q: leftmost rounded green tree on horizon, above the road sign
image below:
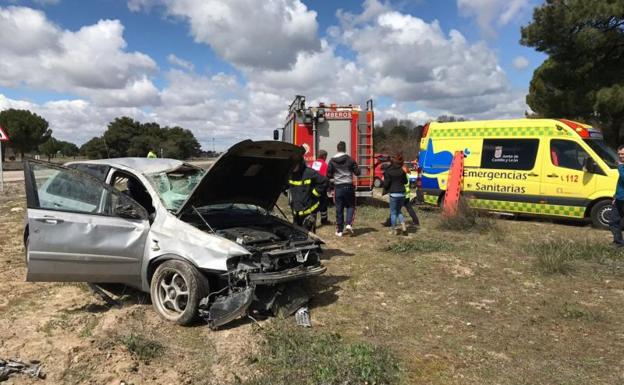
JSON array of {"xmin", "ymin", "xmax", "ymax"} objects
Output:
[{"xmin": 0, "ymin": 108, "xmax": 52, "ymax": 160}]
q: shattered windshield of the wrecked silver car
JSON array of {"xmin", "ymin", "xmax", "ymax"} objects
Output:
[{"xmin": 147, "ymin": 166, "xmax": 206, "ymax": 211}]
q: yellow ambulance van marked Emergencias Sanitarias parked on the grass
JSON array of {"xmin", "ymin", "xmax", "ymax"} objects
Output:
[{"xmin": 419, "ymin": 119, "xmax": 618, "ymax": 228}]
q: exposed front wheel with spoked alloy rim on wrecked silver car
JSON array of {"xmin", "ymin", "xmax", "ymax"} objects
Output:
[{"xmin": 150, "ymin": 260, "xmax": 209, "ymax": 325}]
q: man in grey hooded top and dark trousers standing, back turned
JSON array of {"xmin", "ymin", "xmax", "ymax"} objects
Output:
[{"xmin": 327, "ymin": 141, "xmax": 360, "ymax": 237}]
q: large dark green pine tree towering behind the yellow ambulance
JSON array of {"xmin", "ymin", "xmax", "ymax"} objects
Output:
[{"xmin": 520, "ymin": 0, "xmax": 624, "ymax": 146}]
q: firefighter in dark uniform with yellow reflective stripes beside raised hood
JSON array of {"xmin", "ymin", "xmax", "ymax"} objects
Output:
[{"xmin": 288, "ymin": 158, "xmax": 327, "ymax": 232}]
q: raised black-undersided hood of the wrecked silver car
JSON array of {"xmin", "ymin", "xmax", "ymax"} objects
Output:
[{"xmin": 178, "ymin": 140, "xmax": 304, "ymax": 214}]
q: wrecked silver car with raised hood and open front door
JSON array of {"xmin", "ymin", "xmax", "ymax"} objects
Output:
[{"xmin": 24, "ymin": 140, "xmax": 326, "ymax": 328}]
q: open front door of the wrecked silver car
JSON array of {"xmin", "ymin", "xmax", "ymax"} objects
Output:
[{"xmin": 24, "ymin": 161, "xmax": 149, "ymax": 285}]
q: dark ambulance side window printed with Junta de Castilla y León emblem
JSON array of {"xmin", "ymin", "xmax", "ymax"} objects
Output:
[{"xmin": 481, "ymin": 139, "xmax": 539, "ymax": 170}]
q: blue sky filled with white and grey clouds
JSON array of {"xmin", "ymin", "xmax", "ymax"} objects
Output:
[{"xmin": 0, "ymin": 0, "xmax": 545, "ymax": 150}]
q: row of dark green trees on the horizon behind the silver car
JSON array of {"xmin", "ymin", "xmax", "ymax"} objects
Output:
[{"xmin": 0, "ymin": 109, "xmax": 201, "ymax": 161}]
